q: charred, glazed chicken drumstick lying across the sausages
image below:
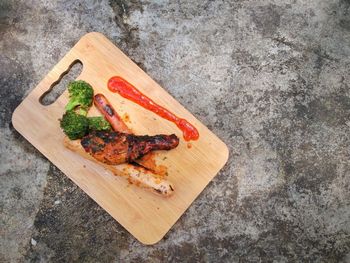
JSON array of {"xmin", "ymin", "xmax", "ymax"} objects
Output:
[{"xmin": 81, "ymin": 131, "xmax": 179, "ymax": 164}]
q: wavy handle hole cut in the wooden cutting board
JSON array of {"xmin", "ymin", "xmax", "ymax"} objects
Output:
[{"xmin": 39, "ymin": 59, "xmax": 83, "ymax": 106}]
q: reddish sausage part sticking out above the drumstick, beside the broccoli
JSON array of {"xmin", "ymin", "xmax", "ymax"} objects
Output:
[{"xmin": 94, "ymin": 93, "xmax": 132, "ymax": 133}]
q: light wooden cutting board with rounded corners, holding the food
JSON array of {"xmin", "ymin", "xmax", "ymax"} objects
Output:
[{"xmin": 12, "ymin": 33, "xmax": 228, "ymax": 244}]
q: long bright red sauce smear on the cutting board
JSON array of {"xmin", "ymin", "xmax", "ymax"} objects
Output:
[{"xmin": 108, "ymin": 77, "xmax": 199, "ymax": 141}]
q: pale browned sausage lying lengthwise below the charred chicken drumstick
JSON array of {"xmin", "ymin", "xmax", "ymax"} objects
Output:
[{"xmin": 64, "ymin": 137, "xmax": 174, "ymax": 197}]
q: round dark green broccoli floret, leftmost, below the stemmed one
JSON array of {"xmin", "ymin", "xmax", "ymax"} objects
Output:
[{"xmin": 60, "ymin": 111, "xmax": 89, "ymax": 140}]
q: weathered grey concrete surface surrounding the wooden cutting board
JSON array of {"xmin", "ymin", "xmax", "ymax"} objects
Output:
[{"xmin": 0, "ymin": 0, "xmax": 350, "ymax": 262}]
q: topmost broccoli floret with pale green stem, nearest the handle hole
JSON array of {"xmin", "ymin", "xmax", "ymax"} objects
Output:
[{"xmin": 66, "ymin": 80, "xmax": 94, "ymax": 116}]
